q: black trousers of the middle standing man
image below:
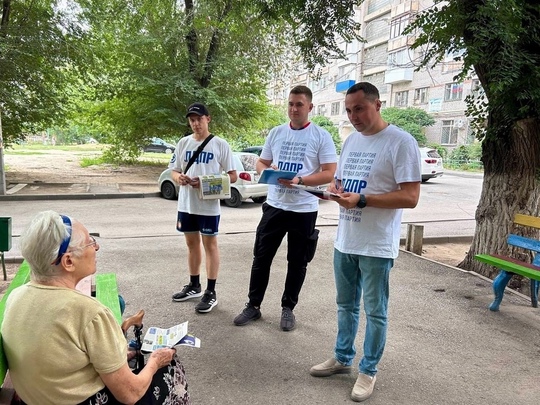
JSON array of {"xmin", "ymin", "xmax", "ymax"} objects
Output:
[{"xmin": 248, "ymin": 203, "xmax": 318, "ymax": 309}]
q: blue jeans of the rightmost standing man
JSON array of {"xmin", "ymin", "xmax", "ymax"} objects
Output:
[{"xmin": 334, "ymin": 249, "xmax": 394, "ymax": 376}]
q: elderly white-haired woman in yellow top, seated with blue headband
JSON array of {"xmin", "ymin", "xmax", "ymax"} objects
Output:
[{"xmin": 2, "ymin": 211, "xmax": 191, "ymax": 405}]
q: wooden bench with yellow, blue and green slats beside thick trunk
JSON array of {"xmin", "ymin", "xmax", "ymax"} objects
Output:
[{"xmin": 475, "ymin": 214, "xmax": 540, "ymax": 311}]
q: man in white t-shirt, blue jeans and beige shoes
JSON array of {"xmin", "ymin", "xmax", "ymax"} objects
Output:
[{"xmin": 310, "ymin": 82, "xmax": 421, "ymax": 402}]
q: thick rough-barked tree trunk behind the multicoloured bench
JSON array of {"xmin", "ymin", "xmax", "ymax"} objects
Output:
[{"xmin": 458, "ymin": 118, "xmax": 540, "ymax": 287}]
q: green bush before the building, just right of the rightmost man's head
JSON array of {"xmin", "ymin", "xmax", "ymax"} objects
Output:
[{"xmin": 381, "ymin": 107, "xmax": 435, "ymax": 146}]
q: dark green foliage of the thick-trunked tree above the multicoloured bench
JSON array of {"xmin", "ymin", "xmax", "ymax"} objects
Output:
[{"xmin": 406, "ymin": 0, "xmax": 540, "ymax": 143}]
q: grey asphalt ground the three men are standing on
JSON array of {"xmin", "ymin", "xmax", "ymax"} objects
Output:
[{"xmin": 0, "ymin": 181, "xmax": 540, "ymax": 405}]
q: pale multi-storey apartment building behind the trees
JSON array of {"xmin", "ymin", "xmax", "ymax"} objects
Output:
[{"xmin": 270, "ymin": 0, "xmax": 481, "ymax": 149}]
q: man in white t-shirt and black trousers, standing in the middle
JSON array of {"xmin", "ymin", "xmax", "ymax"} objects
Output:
[{"xmin": 234, "ymin": 86, "xmax": 337, "ymax": 331}]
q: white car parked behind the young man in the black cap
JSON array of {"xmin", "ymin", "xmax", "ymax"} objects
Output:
[{"xmin": 158, "ymin": 152, "xmax": 268, "ymax": 208}]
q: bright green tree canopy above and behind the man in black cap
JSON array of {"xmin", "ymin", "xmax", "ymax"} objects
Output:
[{"xmin": 0, "ymin": 0, "xmax": 362, "ymax": 155}]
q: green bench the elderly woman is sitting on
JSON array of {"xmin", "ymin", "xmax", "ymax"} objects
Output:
[{"xmin": 0, "ymin": 261, "xmax": 122, "ymax": 405}]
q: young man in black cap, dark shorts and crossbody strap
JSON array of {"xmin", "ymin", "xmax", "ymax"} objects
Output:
[{"xmin": 169, "ymin": 103, "xmax": 237, "ymax": 313}]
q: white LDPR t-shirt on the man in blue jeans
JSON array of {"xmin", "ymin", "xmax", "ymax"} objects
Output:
[{"xmin": 334, "ymin": 125, "xmax": 422, "ymax": 258}]
